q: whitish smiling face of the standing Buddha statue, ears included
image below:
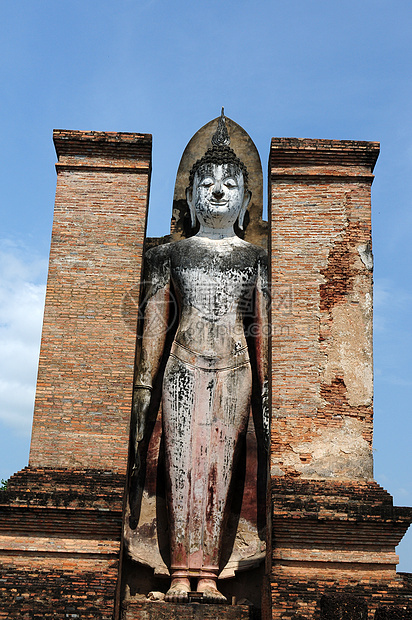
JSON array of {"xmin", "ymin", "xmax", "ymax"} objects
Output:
[{"xmin": 187, "ymin": 164, "xmax": 250, "ymax": 230}]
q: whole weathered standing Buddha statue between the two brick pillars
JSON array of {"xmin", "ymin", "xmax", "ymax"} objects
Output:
[{"xmin": 130, "ymin": 110, "xmax": 269, "ymax": 602}]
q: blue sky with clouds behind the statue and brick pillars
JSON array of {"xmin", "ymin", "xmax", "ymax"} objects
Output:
[{"xmin": 0, "ymin": 0, "xmax": 412, "ymax": 572}]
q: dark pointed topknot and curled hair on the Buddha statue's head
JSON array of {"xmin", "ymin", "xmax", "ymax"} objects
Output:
[{"xmin": 189, "ymin": 108, "xmax": 248, "ymax": 189}]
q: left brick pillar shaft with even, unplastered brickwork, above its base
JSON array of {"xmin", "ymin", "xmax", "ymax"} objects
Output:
[{"xmin": 30, "ymin": 130, "xmax": 151, "ymax": 473}]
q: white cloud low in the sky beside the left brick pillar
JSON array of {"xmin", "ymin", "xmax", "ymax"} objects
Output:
[{"xmin": 0, "ymin": 240, "xmax": 47, "ymax": 435}]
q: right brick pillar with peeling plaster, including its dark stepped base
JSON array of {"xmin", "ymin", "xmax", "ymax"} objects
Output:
[{"xmin": 264, "ymin": 138, "xmax": 412, "ymax": 620}]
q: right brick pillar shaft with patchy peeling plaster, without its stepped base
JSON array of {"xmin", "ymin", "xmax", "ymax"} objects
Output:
[{"xmin": 269, "ymin": 138, "xmax": 379, "ymax": 480}]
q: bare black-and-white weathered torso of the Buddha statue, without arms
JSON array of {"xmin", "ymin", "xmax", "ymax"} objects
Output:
[{"xmin": 165, "ymin": 236, "xmax": 265, "ymax": 358}]
